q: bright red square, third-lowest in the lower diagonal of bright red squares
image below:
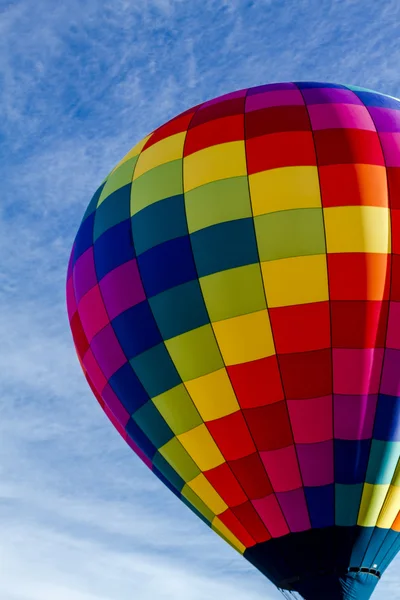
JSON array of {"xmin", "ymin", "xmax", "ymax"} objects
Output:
[{"xmin": 206, "ymin": 411, "xmax": 255, "ymax": 460}]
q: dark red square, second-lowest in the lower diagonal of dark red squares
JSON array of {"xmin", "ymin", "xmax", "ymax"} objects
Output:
[{"xmin": 229, "ymin": 452, "xmax": 272, "ymax": 500}]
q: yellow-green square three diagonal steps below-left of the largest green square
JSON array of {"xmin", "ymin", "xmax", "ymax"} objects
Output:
[{"xmin": 153, "ymin": 385, "xmax": 203, "ymax": 435}]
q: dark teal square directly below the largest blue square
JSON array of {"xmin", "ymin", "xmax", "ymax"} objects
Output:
[{"xmin": 149, "ymin": 279, "xmax": 209, "ymax": 340}]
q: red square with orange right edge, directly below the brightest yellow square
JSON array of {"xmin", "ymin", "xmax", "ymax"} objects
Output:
[{"xmin": 327, "ymin": 252, "xmax": 391, "ymax": 300}]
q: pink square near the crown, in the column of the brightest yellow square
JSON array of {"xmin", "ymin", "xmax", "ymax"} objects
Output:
[{"xmin": 308, "ymin": 104, "xmax": 375, "ymax": 131}]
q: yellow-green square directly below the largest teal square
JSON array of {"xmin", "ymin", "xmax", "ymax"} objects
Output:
[{"xmin": 200, "ymin": 263, "xmax": 267, "ymax": 321}]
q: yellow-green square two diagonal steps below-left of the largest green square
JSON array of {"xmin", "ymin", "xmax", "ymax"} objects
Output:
[{"xmin": 165, "ymin": 325, "xmax": 224, "ymax": 381}]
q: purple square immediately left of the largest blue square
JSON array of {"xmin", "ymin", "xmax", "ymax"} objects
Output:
[{"xmin": 100, "ymin": 260, "xmax": 146, "ymax": 320}]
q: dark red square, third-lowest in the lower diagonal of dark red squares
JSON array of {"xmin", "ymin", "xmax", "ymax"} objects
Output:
[{"xmin": 243, "ymin": 401, "xmax": 293, "ymax": 451}]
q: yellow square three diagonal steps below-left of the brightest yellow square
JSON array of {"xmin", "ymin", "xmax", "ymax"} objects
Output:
[{"xmin": 185, "ymin": 369, "xmax": 240, "ymax": 421}]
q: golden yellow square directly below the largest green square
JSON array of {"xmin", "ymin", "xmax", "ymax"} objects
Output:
[{"xmin": 261, "ymin": 254, "xmax": 329, "ymax": 308}]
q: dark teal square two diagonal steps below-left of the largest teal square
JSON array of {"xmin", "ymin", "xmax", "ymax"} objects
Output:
[{"xmin": 130, "ymin": 344, "xmax": 182, "ymax": 398}]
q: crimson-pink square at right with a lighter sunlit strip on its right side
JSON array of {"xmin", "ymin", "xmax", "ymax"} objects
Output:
[{"xmin": 332, "ymin": 348, "xmax": 383, "ymax": 395}]
